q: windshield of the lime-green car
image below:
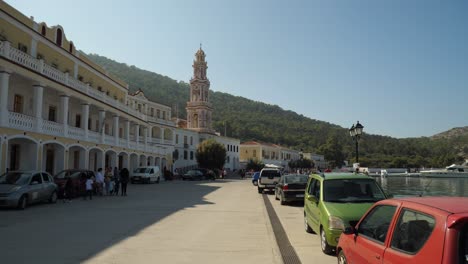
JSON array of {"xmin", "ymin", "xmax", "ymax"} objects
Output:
[{"xmin": 323, "ymin": 179, "xmax": 385, "ymax": 203}]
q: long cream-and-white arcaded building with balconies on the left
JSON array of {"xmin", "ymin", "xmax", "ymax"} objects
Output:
[{"xmin": 0, "ymin": 1, "xmax": 176, "ymax": 174}]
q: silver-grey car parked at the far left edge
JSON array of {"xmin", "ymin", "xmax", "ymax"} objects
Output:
[{"xmin": 0, "ymin": 171, "xmax": 57, "ymax": 209}]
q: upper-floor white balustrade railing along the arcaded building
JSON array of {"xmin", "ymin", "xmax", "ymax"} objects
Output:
[{"xmin": 0, "ymin": 41, "xmax": 168, "ymax": 125}]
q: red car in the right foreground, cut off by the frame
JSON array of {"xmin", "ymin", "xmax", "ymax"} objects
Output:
[{"xmin": 336, "ymin": 197, "xmax": 468, "ymax": 264}]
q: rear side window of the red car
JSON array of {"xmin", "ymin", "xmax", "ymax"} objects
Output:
[{"xmin": 391, "ymin": 209, "xmax": 435, "ymax": 253}]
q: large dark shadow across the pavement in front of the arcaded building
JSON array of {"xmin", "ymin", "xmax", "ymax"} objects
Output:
[{"xmin": 0, "ymin": 180, "xmax": 223, "ymax": 264}]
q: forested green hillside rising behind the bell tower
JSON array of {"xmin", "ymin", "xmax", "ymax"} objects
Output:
[{"xmin": 88, "ymin": 54, "xmax": 468, "ymax": 167}]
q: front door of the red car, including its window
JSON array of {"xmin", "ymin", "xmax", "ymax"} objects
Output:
[{"xmin": 348, "ymin": 204, "xmax": 398, "ymax": 263}]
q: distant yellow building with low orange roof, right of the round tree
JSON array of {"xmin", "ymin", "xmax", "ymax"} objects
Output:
[{"xmin": 239, "ymin": 141, "xmax": 300, "ymax": 169}]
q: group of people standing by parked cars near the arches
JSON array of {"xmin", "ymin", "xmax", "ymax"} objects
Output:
[{"xmin": 84, "ymin": 167, "xmax": 130, "ymax": 200}]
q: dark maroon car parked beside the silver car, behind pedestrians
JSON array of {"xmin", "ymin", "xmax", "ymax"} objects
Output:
[{"xmin": 54, "ymin": 169, "xmax": 95, "ymax": 198}]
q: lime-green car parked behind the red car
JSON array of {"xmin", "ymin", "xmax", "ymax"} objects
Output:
[{"xmin": 304, "ymin": 173, "xmax": 387, "ymax": 254}]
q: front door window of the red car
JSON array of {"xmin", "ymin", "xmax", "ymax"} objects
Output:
[{"xmin": 358, "ymin": 205, "xmax": 396, "ymax": 244}]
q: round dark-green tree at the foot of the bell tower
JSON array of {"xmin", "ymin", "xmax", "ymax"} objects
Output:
[{"xmin": 195, "ymin": 139, "xmax": 226, "ymax": 169}]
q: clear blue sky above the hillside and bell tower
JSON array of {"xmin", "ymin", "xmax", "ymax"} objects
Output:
[{"xmin": 6, "ymin": 0, "xmax": 468, "ymax": 137}]
